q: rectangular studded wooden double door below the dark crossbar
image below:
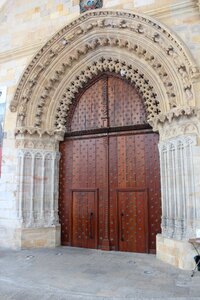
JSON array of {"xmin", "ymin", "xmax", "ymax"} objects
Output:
[{"xmin": 59, "ymin": 75, "xmax": 160, "ymax": 252}]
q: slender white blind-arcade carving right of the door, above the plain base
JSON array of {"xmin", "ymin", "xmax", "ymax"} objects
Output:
[{"xmin": 159, "ymin": 136, "xmax": 197, "ymax": 240}]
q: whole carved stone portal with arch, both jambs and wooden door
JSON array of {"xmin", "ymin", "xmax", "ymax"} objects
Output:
[{"xmin": 8, "ymin": 9, "xmax": 200, "ymax": 268}]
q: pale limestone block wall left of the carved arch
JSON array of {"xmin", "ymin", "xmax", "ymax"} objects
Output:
[{"xmin": 0, "ymin": 0, "xmax": 79, "ymax": 248}]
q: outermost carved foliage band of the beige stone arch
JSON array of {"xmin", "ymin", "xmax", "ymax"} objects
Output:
[{"xmin": 10, "ymin": 10, "xmax": 199, "ymax": 131}]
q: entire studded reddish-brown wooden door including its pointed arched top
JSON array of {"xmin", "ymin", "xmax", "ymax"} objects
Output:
[{"xmin": 59, "ymin": 73, "xmax": 161, "ymax": 252}]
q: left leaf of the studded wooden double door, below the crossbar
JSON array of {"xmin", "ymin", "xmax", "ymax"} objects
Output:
[{"xmin": 59, "ymin": 137, "xmax": 108, "ymax": 248}]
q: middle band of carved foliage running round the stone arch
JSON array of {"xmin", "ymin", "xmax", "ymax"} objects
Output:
[{"xmin": 18, "ymin": 37, "xmax": 172, "ymax": 126}]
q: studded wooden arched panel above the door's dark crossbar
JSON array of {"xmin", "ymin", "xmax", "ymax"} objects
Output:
[{"xmin": 67, "ymin": 74, "xmax": 147, "ymax": 132}]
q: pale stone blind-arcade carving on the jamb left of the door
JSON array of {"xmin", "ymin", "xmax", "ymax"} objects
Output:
[{"xmin": 17, "ymin": 147, "xmax": 59, "ymax": 228}]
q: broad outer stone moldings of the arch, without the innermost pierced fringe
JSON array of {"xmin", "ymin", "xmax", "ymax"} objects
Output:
[{"xmin": 10, "ymin": 10, "xmax": 199, "ymax": 131}]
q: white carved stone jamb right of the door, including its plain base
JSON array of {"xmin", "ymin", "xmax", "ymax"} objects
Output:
[{"xmin": 157, "ymin": 131, "xmax": 200, "ymax": 269}]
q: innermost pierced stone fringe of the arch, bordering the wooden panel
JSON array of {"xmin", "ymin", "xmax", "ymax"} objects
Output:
[{"xmin": 35, "ymin": 57, "xmax": 160, "ymax": 128}]
